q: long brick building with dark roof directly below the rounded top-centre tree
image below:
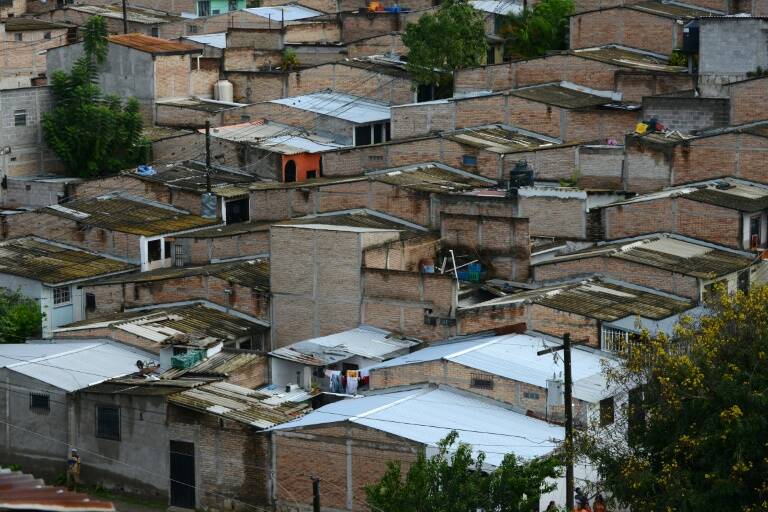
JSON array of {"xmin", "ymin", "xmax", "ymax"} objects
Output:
[{"xmin": 391, "ymin": 82, "xmax": 639, "ymax": 142}]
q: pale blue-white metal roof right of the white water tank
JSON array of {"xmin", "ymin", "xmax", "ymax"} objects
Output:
[{"xmin": 270, "ymin": 91, "xmax": 390, "ymax": 124}]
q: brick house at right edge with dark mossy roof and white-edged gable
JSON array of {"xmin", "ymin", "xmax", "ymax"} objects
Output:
[{"xmin": 600, "ymin": 178, "xmax": 768, "ymax": 251}]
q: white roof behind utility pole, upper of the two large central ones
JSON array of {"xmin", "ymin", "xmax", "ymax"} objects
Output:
[{"xmin": 369, "ymin": 334, "xmax": 611, "ymax": 403}]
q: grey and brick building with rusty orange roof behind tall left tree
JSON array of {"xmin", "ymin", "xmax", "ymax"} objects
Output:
[{"xmin": 47, "ymin": 33, "xmax": 206, "ymax": 124}]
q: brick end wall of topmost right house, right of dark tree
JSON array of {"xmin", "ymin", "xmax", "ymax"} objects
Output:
[{"xmin": 570, "ymin": 8, "xmax": 683, "ymax": 55}]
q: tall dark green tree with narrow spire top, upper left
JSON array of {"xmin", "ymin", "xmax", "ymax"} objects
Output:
[{"xmin": 43, "ymin": 16, "xmax": 147, "ymax": 177}]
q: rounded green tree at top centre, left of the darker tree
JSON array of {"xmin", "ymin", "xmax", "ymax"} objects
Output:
[{"xmin": 403, "ymin": 0, "xmax": 488, "ymax": 86}]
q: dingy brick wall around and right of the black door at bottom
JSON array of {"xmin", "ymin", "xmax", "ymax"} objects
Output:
[{"xmin": 168, "ymin": 404, "xmax": 270, "ymax": 512}]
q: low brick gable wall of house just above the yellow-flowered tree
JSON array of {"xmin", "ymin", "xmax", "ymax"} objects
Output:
[{"xmin": 533, "ymin": 256, "xmax": 699, "ymax": 300}]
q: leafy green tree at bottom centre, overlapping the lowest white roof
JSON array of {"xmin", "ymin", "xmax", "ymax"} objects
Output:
[{"xmin": 366, "ymin": 431, "xmax": 560, "ymax": 512}]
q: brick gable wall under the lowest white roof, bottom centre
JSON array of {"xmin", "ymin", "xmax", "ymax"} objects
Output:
[{"xmin": 272, "ymin": 422, "xmax": 422, "ymax": 512}]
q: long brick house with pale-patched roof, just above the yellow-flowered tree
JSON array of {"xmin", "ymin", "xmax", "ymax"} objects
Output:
[{"xmin": 531, "ymin": 233, "xmax": 764, "ymax": 301}]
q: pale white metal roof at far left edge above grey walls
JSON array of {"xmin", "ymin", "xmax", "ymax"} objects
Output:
[{"xmin": 0, "ymin": 342, "xmax": 151, "ymax": 391}]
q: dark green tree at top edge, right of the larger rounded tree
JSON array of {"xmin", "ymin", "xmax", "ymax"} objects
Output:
[{"xmin": 501, "ymin": 0, "xmax": 574, "ymax": 59}]
